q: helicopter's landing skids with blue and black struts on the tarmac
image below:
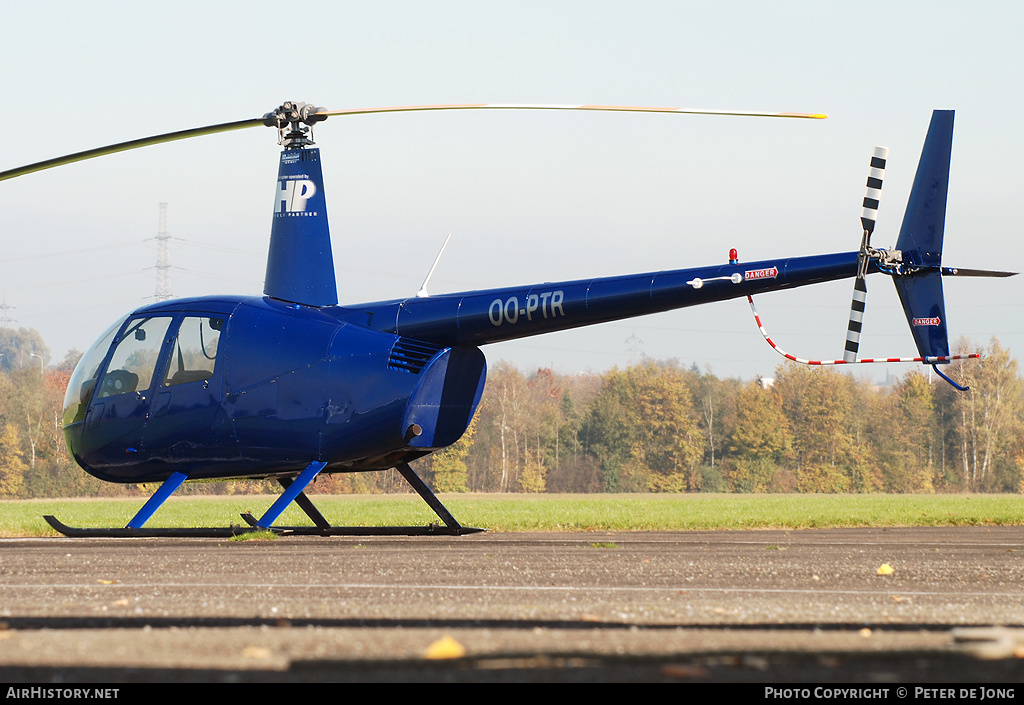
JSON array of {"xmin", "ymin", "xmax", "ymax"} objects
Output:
[{"xmin": 43, "ymin": 463, "xmax": 485, "ymax": 538}]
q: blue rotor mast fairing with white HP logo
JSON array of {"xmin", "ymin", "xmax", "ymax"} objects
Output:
[{"xmin": 263, "ymin": 149, "xmax": 338, "ymax": 306}]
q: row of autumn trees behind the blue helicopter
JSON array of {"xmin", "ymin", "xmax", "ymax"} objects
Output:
[{"xmin": 0, "ymin": 329, "xmax": 1024, "ymax": 498}]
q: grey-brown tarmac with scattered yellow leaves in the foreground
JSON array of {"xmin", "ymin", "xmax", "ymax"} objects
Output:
[{"xmin": 0, "ymin": 527, "xmax": 1024, "ymax": 692}]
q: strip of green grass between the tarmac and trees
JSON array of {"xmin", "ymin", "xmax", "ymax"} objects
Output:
[{"xmin": 0, "ymin": 494, "xmax": 1024, "ymax": 537}]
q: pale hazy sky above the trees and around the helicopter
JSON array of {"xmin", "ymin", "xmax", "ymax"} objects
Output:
[{"xmin": 0, "ymin": 0, "xmax": 1024, "ymax": 380}]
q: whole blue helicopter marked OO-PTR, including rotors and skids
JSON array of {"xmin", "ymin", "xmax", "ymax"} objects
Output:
[{"xmin": 0, "ymin": 102, "xmax": 1010, "ymax": 536}]
